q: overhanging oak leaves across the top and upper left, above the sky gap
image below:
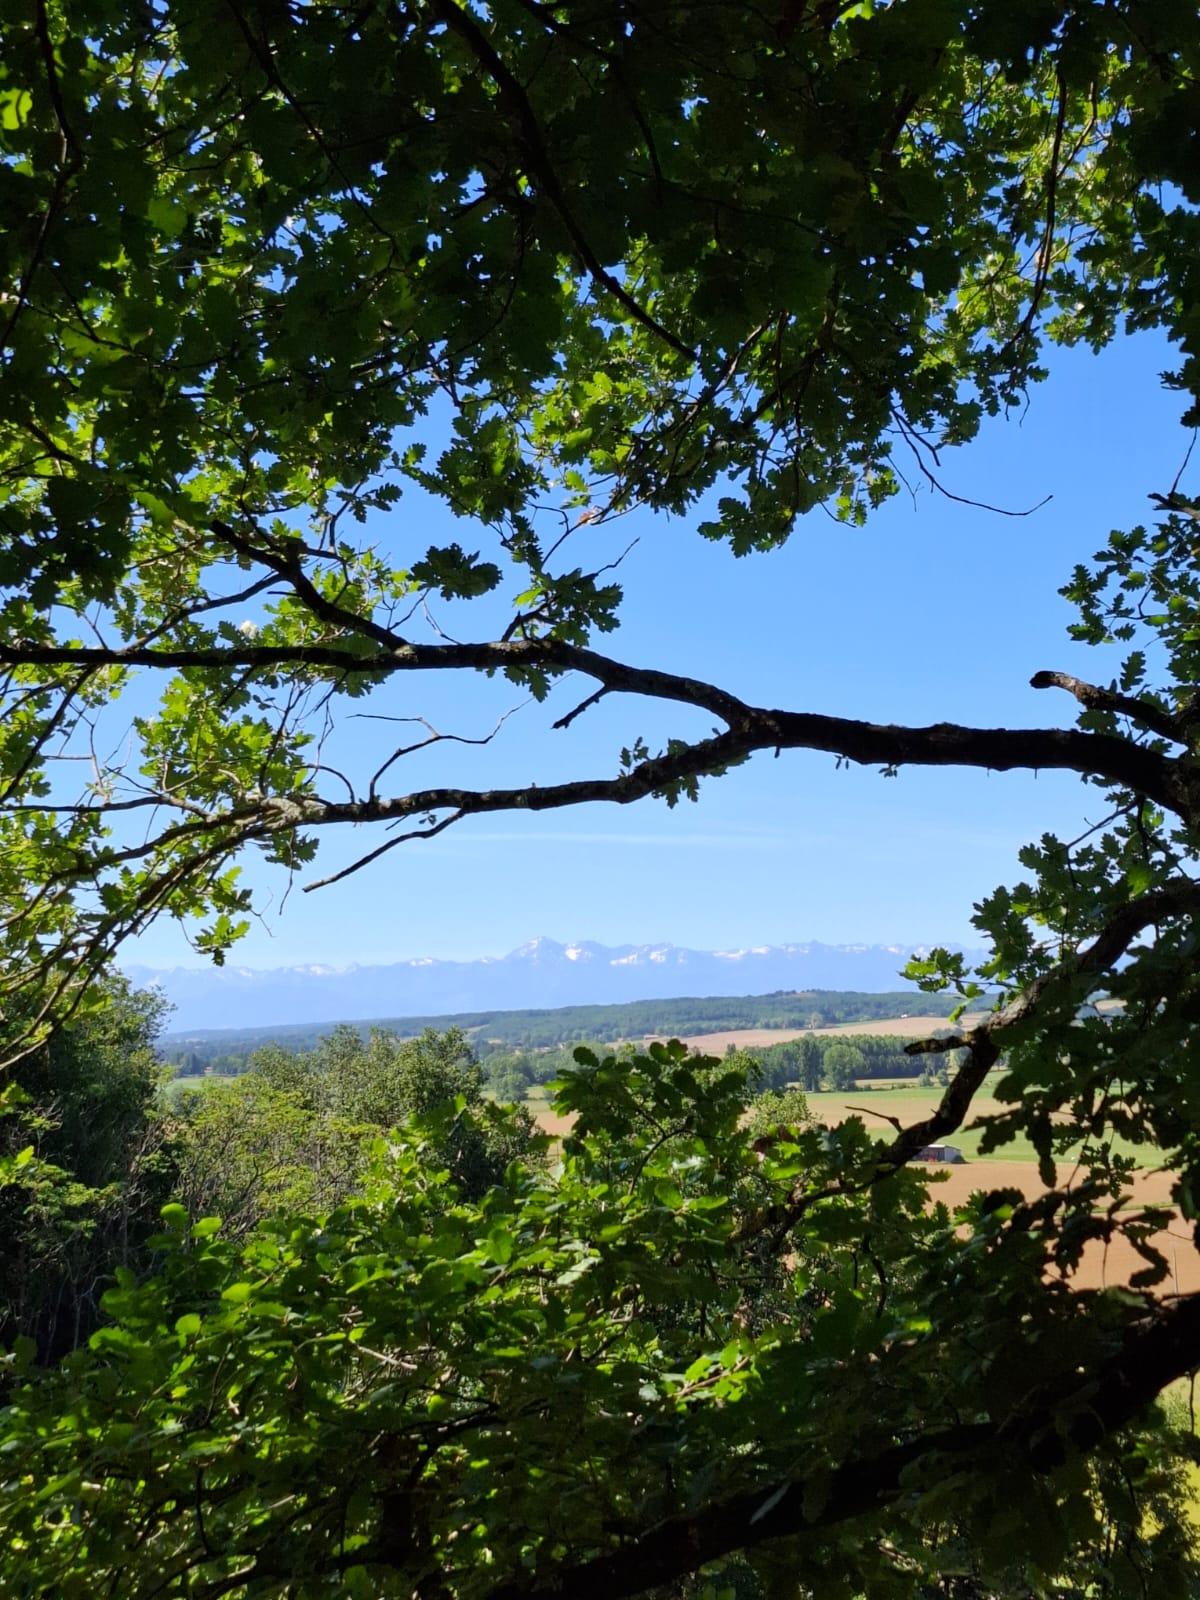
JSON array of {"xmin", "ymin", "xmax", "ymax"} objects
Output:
[{"xmin": 0, "ymin": 0, "xmax": 1200, "ymax": 1017}]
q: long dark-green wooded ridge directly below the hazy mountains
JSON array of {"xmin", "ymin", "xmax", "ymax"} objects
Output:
[{"xmin": 160, "ymin": 989, "xmax": 955, "ymax": 1080}]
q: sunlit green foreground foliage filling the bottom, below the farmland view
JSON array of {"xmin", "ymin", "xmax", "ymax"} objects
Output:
[{"xmin": 0, "ymin": 1046, "xmax": 1197, "ymax": 1600}]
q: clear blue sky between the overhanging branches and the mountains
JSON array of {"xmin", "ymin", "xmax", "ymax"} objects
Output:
[{"xmin": 125, "ymin": 339, "xmax": 1187, "ymax": 966}]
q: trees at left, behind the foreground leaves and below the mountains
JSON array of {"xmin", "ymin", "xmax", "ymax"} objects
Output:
[{"xmin": 0, "ymin": 978, "xmax": 536, "ymax": 1356}]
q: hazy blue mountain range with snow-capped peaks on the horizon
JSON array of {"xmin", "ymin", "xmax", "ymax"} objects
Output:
[{"xmin": 126, "ymin": 939, "xmax": 982, "ymax": 1034}]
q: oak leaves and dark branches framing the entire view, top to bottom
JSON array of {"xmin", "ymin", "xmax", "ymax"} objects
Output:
[{"xmin": 0, "ymin": 0, "xmax": 1200, "ymax": 1597}]
